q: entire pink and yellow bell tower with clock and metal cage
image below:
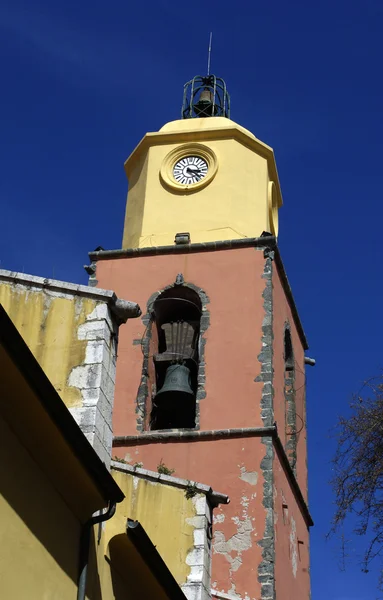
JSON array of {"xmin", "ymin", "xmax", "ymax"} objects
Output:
[{"xmin": 88, "ymin": 75, "xmax": 312, "ymax": 600}]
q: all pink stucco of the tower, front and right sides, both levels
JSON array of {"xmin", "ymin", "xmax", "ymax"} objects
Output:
[{"xmin": 97, "ymin": 248, "xmax": 309, "ymax": 600}]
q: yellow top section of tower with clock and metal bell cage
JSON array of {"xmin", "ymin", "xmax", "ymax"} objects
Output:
[{"xmin": 123, "ymin": 75, "xmax": 282, "ymax": 248}]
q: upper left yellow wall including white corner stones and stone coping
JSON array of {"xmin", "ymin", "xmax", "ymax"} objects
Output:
[{"xmin": 0, "ymin": 270, "xmax": 139, "ymax": 465}]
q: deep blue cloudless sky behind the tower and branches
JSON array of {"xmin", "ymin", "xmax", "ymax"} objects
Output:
[{"xmin": 0, "ymin": 0, "xmax": 383, "ymax": 600}]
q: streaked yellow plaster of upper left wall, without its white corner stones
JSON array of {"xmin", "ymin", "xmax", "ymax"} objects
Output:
[{"xmin": 0, "ymin": 282, "xmax": 97, "ymax": 407}]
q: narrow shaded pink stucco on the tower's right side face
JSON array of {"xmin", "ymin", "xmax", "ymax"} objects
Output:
[{"xmin": 273, "ymin": 265, "xmax": 310, "ymax": 600}]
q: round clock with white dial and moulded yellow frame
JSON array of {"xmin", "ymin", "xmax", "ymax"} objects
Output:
[{"xmin": 160, "ymin": 143, "xmax": 218, "ymax": 193}]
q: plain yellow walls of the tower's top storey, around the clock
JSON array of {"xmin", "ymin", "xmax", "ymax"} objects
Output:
[{"xmin": 123, "ymin": 117, "xmax": 282, "ymax": 248}]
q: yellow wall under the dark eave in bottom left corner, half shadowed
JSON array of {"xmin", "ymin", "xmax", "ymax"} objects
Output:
[{"xmin": 0, "ymin": 417, "xmax": 80, "ymax": 600}]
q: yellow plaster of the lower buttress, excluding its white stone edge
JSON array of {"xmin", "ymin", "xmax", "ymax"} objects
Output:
[{"xmin": 105, "ymin": 470, "xmax": 196, "ymax": 585}]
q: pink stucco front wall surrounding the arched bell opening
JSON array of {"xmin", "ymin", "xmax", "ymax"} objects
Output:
[{"xmin": 97, "ymin": 248, "xmax": 265, "ymax": 435}]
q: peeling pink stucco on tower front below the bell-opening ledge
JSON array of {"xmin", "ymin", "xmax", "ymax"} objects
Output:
[{"xmin": 115, "ymin": 438, "xmax": 265, "ymax": 600}]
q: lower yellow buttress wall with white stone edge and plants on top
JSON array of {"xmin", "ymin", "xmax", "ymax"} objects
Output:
[{"xmin": 107, "ymin": 461, "xmax": 228, "ymax": 600}]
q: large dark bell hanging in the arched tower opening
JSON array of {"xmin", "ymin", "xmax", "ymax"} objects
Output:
[{"xmin": 155, "ymin": 365, "xmax": 194, "ymax": 407}]
